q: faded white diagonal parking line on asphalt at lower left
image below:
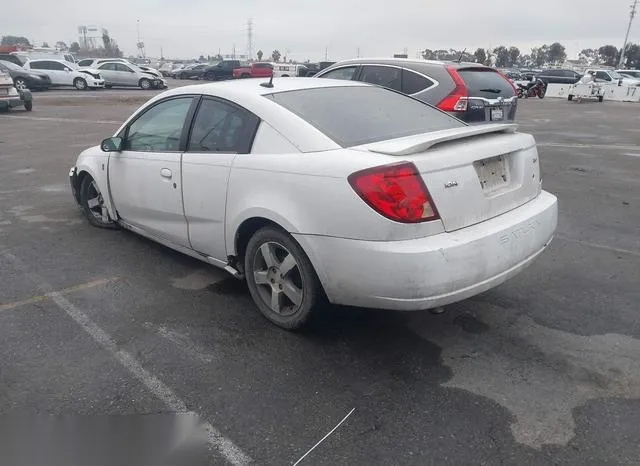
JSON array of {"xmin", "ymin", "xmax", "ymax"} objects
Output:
[{"xmin": 3, "ymin": 253, "xmax": 252, "ymax": 465}]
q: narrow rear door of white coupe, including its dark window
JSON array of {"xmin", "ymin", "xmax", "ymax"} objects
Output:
[{"xmin": 182, "ymin": 97, "xmax": 260, "ymax": 262}]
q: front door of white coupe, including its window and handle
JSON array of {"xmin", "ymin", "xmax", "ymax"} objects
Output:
[{"xmin": 108, "ymin": 96, "xmax": 195, "ymax": 246}]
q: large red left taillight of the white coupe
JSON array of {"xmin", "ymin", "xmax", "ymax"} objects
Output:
[{"xmin": 349, "ymin": 162, "xmax": 440, "ymax": 223}]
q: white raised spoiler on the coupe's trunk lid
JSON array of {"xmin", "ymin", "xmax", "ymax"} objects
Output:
[{"xmin": 361, "ymin": 123, "xmax": 518, "ymax": 155}]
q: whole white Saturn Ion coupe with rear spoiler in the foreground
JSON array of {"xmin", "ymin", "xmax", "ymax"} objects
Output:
[{"xmin": 70, "ymin": 78, "xmax": 558, "ymax": 329}]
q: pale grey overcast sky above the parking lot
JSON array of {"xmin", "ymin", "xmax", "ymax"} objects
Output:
[{"xmin": 0, "ymin": 0, "xmax": 640, "ymax": 60}]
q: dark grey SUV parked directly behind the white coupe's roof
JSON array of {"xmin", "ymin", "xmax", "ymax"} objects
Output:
[{"xmin": 314, "ymin": 58, "xmax": 518, "ymax": 123}]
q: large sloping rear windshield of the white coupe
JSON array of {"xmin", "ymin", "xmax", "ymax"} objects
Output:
[{"xmin": 266, "ymin": 86, "xmax": 465, "ymax": 147}]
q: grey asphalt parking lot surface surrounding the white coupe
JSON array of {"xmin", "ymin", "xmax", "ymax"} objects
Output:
[{"xmin": 0, "ymin": 84, "xmax": 640, "ymax": 465}]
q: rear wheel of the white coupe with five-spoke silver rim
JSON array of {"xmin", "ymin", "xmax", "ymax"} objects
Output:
[{"xmin": 244, "ymin": 227, "xmax": 324, "ymax": 330}]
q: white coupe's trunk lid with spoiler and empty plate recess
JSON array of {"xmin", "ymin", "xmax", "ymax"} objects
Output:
[{"xmin": 355, "ymin": 124, "xmax": 541, "ymax": 231}]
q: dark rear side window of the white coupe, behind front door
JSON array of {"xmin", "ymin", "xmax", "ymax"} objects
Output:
[{"xmin": 187, "ymin": 99, "xmax": 259, "ymax": 154}]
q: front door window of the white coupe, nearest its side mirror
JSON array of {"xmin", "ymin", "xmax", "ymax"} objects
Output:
[{"xmin": 124, "ymin": 97, "xmax": 193, "ymax": 152}]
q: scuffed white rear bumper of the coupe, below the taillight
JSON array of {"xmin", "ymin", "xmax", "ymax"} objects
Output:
[{"xmin": 294, "ymin": 191, "xmax": 558, "ymax": 311}]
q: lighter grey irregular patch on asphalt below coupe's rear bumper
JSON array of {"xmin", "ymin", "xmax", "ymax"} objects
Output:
[{"xmin": 408, "ymin": 301, "xmax": 640, "ymax": 448}]
